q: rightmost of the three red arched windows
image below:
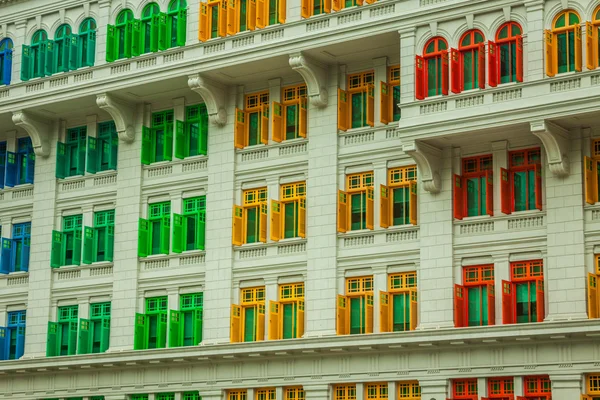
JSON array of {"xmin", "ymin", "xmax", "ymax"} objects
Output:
[{"xmin": 488, "ymin": 22, "xmax": 523, "ymax": 87}]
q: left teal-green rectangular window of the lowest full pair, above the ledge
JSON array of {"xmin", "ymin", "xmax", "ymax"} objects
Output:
[{"xmin": 46, "ymin": 305, "xmax": 79, "ymax": 357}]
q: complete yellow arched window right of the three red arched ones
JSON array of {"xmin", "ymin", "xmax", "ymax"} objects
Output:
[{"xmin": 545, "ymin": 10, "xmax": 581, "ymax": 76}]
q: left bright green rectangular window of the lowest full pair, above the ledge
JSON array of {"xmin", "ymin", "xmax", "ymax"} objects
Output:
[{"xmin": 133, "ymin": 296, "xmax": 168, "ymax": 350}]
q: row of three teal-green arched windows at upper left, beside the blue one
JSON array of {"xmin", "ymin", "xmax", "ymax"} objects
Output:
[{"xmin": 19, "ymin": 18, "xmax": 96, "ymax": 81}]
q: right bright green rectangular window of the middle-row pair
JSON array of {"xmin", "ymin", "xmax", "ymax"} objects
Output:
[{"xmin": 173, "ymin": 196, "xmax": 206, "ymax": 253}]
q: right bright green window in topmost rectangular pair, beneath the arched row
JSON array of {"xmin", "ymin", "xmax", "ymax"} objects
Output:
[{"xmin": 175, "ymin": 104, "xmax": 208, "ymax": 159}]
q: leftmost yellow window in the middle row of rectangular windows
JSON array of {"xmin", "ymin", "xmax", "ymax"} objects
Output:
[{"xmin": 233, "ymin": 187, "xmax": 267, "ymax": 246}]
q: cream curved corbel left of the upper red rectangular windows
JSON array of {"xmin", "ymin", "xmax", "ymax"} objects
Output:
[{"xmin": 402, "ymin": 140, "xmax": 442, "ymax": 193}]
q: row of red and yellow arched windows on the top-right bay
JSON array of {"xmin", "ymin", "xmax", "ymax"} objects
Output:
[{"xmin": 415, "ymin": 7, "xmax": 600, "ymax": 100}]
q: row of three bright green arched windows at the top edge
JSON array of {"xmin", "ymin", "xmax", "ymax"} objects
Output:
[{"xmin": 106, "ymin": 0, "xmax": 187, "ymax": 62}]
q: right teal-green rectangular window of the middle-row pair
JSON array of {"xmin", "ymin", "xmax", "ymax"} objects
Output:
[{"xmin": 83, "ymin": 210, "xmax": 115, "ymax": 264}]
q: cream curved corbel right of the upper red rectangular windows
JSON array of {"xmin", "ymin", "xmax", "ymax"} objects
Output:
[{"xmin": 530, "ymin": 120, "xmax": 569, "ymax": 177}]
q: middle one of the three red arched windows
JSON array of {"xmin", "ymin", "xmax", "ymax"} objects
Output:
[{"xmin": 458, "ymin": 29, "xmax": 485, "ymax": 93}]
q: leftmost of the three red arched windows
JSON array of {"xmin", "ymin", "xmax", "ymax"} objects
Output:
[{"xmin": 415, "ymin": 37, "xmax": 448, "ymax": 100}]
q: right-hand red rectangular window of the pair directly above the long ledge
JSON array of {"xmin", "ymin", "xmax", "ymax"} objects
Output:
[{"xmin": 502, "ymin": 260, "xmax": 546, "ymax": 324}]
